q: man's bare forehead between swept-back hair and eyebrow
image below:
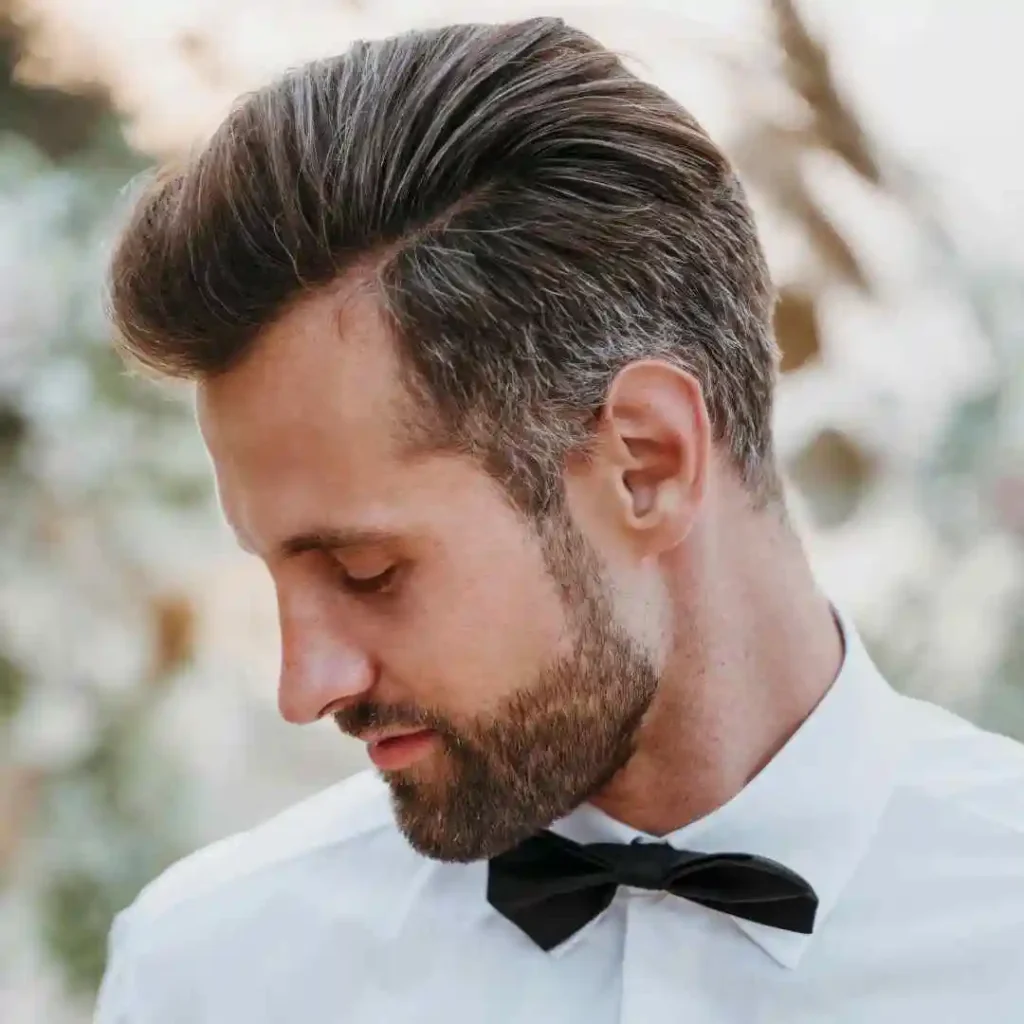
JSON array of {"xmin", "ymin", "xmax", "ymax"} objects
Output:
[{"xmin": 196, "ymin": 284, "xmax": 417, "ymax": 555}]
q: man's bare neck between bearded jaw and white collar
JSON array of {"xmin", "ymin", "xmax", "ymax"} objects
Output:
[{"xmin": 591, "ymin": 507, "xmax": 843, "ymax": 836}]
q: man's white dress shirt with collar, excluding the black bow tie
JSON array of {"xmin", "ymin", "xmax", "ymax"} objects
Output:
[{"xmin": 96, "ymin": 623, "xmax": 1024, "ymax": 1024}]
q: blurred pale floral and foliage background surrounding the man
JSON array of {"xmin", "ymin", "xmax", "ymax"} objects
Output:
[{"xmin": 0, "ymin": 0, "xmax": 1024, "ymax": 1024}]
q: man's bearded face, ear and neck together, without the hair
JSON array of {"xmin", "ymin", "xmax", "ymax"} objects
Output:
[{"xmin": 197, "ymin": 279, "xmax": 842, "ymax": 860}]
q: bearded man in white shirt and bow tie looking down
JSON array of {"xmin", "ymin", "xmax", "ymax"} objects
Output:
[{"xmin": 97, "ymin": 19, "xmax": 1024, "ymax": 1024}]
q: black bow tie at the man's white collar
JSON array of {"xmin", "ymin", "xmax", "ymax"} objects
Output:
[{"xmin": 487, "ymin": 831, "xmax": 818, "ymax": 949}]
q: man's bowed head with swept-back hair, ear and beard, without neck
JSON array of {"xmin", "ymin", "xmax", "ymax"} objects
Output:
[{"xmin": 111, "ymin": 19, "xmax": 778, "ymax": 859}]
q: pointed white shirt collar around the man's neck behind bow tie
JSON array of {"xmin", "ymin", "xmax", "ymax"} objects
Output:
[{"xmin": 551, "ymin": 611, "xmax": 899, "ymax": 968}]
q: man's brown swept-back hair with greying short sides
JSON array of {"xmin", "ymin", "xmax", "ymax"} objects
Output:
[{"xmin": 110, "ymin": 18, "xmax": 777, "ymax": 513}]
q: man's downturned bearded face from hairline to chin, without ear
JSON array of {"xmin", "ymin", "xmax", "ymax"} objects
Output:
[{"xmin": 198, "ymin": 284, "xmax": 657, "ymax": 860}]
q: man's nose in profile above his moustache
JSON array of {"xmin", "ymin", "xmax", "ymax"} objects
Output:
[{"xmin": 278, "ymin": 613, "xmax": 374, "ymax": 725}]
